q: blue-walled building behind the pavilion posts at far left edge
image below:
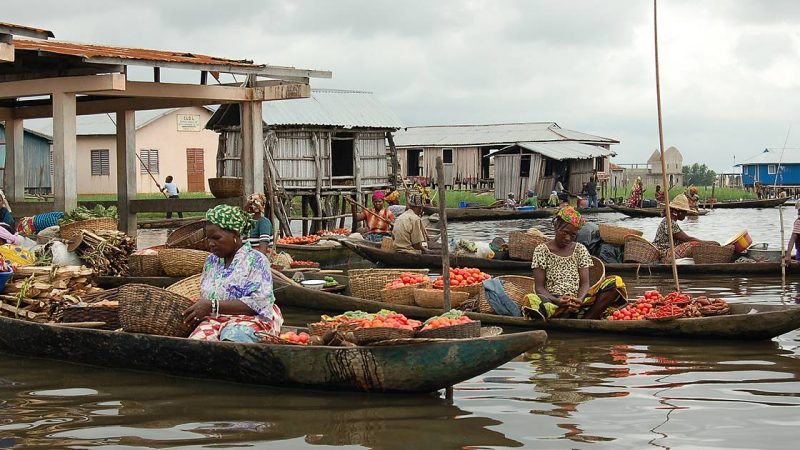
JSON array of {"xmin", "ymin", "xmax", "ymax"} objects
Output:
[{"xmin": 0, "ymin": 123, "xmax": 53, "ymax": 194}]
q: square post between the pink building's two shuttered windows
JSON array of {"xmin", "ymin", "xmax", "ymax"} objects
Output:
[{"xmin": 117, "ymin": 111, "xmax": 137, "ymax": 237}]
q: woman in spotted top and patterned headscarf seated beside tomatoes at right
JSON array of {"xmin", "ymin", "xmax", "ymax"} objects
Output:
[{"xmin": 523, "ymin": 207, "xmax": 627, "ymax": 319}]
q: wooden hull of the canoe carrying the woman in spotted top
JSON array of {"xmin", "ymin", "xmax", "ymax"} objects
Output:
[{"xmin": 275, "ymin": 277, "xmax": 800, "ymax": 339}]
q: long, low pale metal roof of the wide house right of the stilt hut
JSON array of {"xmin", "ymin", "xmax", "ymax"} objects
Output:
[{"xmin": 394, "ymin": 122, "xmax": 619, "ymax": 147}]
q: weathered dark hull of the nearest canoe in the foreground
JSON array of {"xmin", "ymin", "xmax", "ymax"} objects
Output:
[{"xmin": 0, "ymin": 317, "xmax": 547, "ymax": 392}]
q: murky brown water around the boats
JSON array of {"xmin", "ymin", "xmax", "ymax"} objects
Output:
[{"xmin": 0, "ymin": 209, "xmax": 800, "ymax": 449}]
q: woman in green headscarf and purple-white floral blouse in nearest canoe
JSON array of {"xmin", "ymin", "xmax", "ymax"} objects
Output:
[{"xmin": 183, "ymin": 205, "xmax": 283, "ymax": 342}]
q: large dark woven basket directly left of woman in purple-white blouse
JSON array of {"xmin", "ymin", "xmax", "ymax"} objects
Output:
[{"xmin": 119, "ymin": 284, "xmax": 193, "ymax": 337}]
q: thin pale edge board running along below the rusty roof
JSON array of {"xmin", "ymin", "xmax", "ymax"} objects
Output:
[{"xmin": 83, "ymin": 56, "xmax": 333, "ymax": 79}]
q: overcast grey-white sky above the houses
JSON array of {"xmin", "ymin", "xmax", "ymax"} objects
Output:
[{"xmin": 2, "ymin": 0, "xmax": 800, "ymax": 171}]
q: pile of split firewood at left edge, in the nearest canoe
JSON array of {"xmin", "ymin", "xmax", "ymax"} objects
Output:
[{"xmin": 0, "ymin": 266, "xmax": 102, "ymax": 322}]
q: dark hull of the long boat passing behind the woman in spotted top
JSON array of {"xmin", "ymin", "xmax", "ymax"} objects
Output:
[{"xmin": 344, "ymin": 241, "xmax": 800, "ymax": 276}]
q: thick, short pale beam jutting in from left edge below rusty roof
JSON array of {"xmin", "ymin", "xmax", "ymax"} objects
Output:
[{"xmin": 0, "ymin": 73, "xmax": 125, "ymax": 98}]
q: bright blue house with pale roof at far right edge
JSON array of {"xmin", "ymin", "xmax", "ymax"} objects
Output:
[{"xmin": 737, "ymin": 148, "xmax": 800, "ymax": 187}]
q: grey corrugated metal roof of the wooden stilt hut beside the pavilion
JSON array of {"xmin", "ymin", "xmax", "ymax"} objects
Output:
[{"xmin": 262, "ymin": 89, "xmax": 403, "ymax": 129}]
